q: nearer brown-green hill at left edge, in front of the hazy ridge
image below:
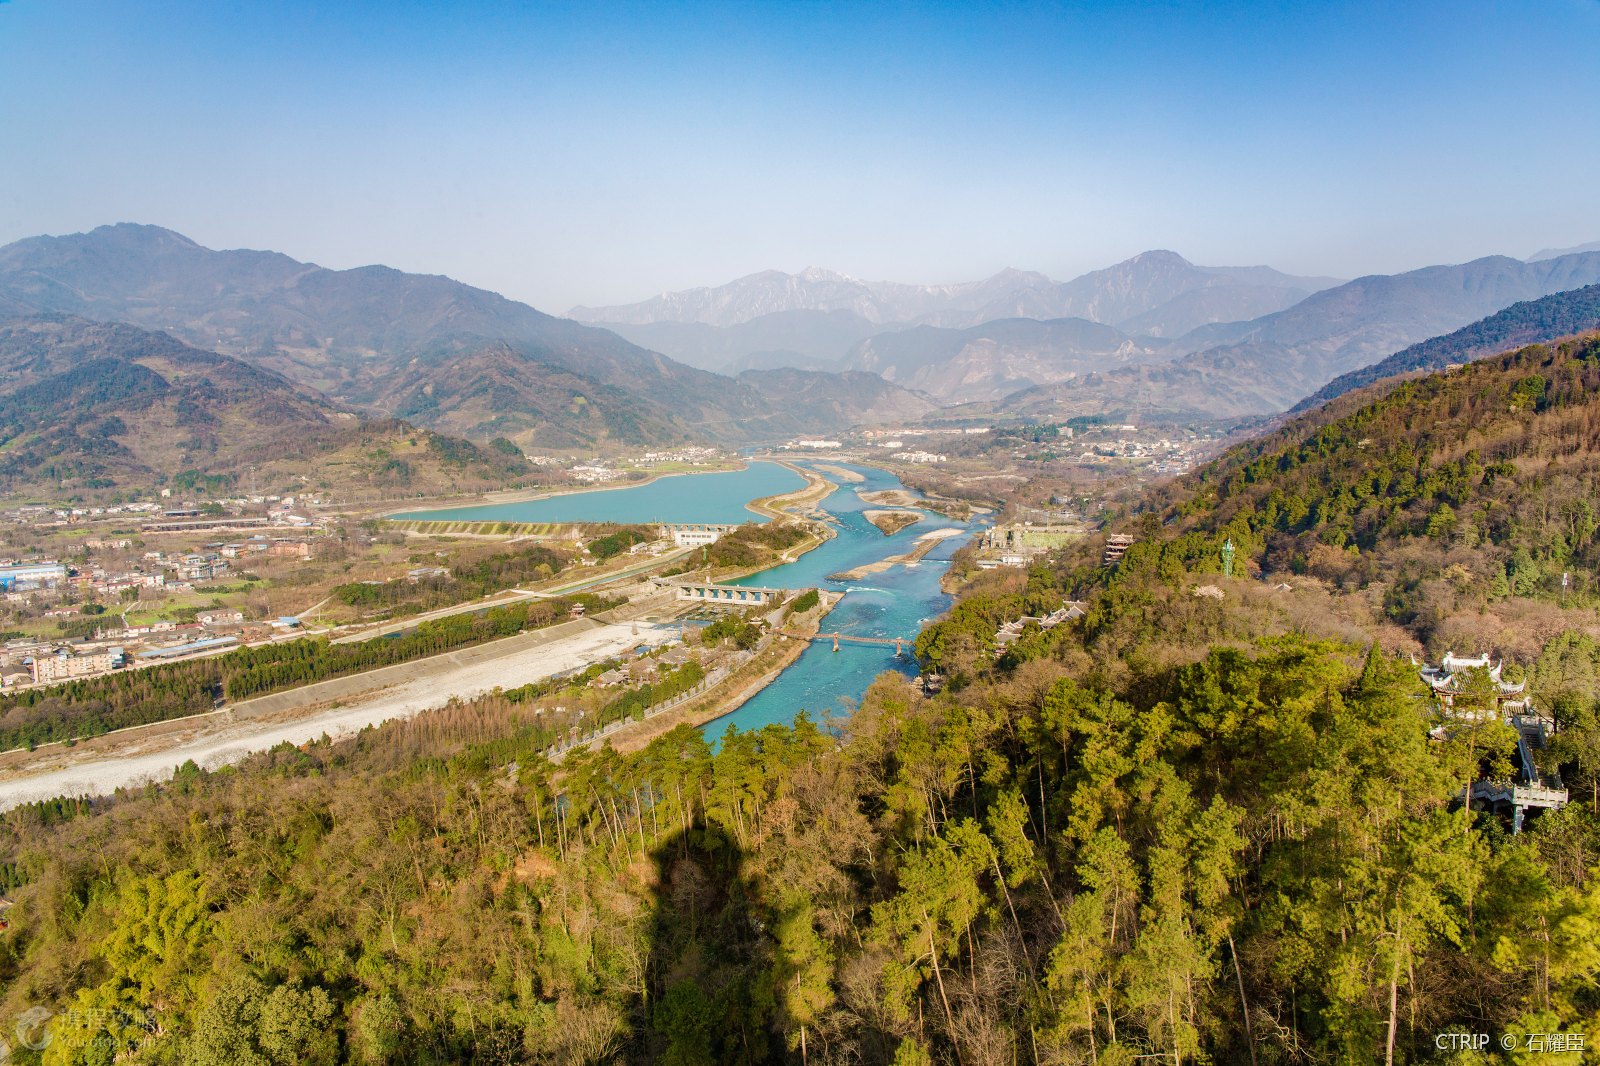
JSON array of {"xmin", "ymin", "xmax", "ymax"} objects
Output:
[{"xmin": 0, "ymin": 314, "xmax": 530, "ymax": 498}]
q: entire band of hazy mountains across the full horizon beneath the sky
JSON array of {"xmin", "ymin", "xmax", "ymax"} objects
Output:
[{"xmin": 0, "ymin": 224, "xmax": 1600, "ymax": 450}]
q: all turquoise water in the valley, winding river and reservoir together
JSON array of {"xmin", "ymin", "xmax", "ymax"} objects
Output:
[{"xmin": 395, "ymin": 461, "xmax": 976, "ymax": 736}]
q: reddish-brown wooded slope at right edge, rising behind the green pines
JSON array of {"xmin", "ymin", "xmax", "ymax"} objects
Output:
[{"xmin": 1131, "ymin": 338, "xmax": 1600, "ymax": 651}]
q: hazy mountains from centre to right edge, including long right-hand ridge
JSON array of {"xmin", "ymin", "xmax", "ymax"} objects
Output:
[{"xmin": 573, "ymin": 246, "xmax": 1600, "ymax": 419}]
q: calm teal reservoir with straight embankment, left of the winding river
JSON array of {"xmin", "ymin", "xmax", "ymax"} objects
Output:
[{"xmin": 390, "ymin": 463, "xmax": 805, "ymax": 523}]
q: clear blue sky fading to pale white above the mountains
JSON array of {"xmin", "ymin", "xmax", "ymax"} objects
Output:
[{"xmin": 0, "ymin": 0, "xmax": 1600, "ymax": 312}]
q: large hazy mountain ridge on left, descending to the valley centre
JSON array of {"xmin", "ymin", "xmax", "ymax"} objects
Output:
[{"xmin": 0, "ymin": 224, "xmax": 923, "ymax": 448}]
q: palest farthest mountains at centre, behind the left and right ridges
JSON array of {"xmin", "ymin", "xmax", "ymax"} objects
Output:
[{"xmin": 571, "ymin": 251, "xmax": 1338, "ymax": 402}]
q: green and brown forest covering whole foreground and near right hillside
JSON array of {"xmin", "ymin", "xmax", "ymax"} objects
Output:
[{"xmin": 0, "ymin": 339, "xmax": 1600, "ymax": 1066}]
